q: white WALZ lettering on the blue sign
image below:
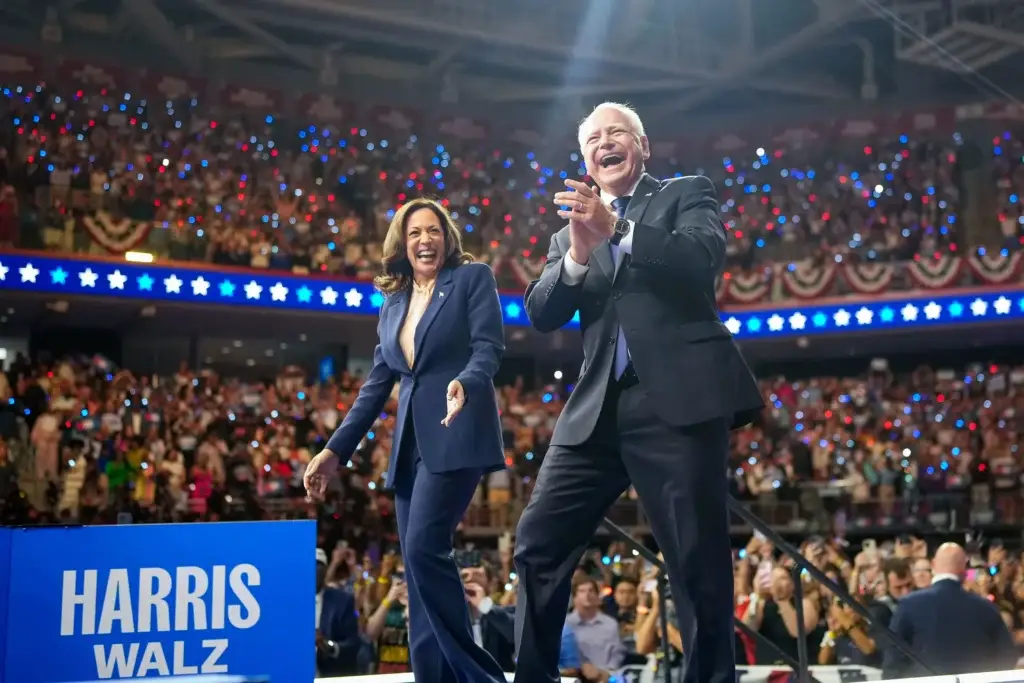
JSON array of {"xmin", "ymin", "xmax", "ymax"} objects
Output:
[{"xmin": 92, "ymin": 638, "xmax": 227, "ymax": 680}]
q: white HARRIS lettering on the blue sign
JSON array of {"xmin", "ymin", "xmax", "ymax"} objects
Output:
[{"xmin": 60, "ymin": 564, "xmax": 260, "ymax": 634}]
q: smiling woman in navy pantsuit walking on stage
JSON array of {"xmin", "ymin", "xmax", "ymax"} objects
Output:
[{"xmin": 305, "ymin": 199, "xmax": 505, "ymax": 683}]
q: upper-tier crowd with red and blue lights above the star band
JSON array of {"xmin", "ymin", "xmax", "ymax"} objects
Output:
[{"xmin": 0, "ymin": 82, "xmax": 999, "ymax": 287}]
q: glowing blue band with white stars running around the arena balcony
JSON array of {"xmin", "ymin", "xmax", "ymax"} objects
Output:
[{"xmin": 0, "ymin": 253, "xmax": 1024, "ymax": 340}]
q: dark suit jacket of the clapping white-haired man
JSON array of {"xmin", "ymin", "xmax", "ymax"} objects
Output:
[{"xmin": 526, "ymin": 174, "xmax": 764, "ymax": 445}]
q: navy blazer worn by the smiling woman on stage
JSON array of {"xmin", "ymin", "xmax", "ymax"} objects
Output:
[{"xmin": 327, "ymin": 263, "xmax": 505, "ymax": 488}]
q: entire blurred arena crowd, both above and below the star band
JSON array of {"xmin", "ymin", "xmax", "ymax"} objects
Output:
[{"xmin": 6, "ymin": 3, "xmax": 1024, "ymax": 681}]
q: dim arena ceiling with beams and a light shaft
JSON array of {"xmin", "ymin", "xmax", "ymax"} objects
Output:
[{"xmin": 0, "ymin": 0, "xmax": 1024, "ymax": 124}]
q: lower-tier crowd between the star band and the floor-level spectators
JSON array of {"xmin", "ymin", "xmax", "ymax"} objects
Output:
[{"xmin": 0, "ymin": 357, "xmax": 1024, "ymax": 532}]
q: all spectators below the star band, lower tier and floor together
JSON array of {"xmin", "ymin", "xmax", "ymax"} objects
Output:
[{"xmin": 0, "ymin": 356, "xmax": 1024, "ymax": 673}]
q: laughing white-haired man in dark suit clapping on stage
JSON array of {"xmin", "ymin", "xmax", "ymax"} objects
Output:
[{"xmin": 515, "ymin": 102, "xmax": 763, "ymax": 683}]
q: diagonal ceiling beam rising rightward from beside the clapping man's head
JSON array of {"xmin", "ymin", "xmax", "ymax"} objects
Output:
[{"xmin": 655, "ymin": 0, "xmax": 863, "ymax": 118}]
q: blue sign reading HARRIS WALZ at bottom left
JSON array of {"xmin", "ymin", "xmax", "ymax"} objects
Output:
[{"xmin": 4, "ymin": 521, "xmax": 316, "ymax": 683}]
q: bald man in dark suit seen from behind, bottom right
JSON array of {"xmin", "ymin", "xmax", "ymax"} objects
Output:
[{"xmin": 882, "ymin": 543, "xmax": 1017, "ymax": 679}]
